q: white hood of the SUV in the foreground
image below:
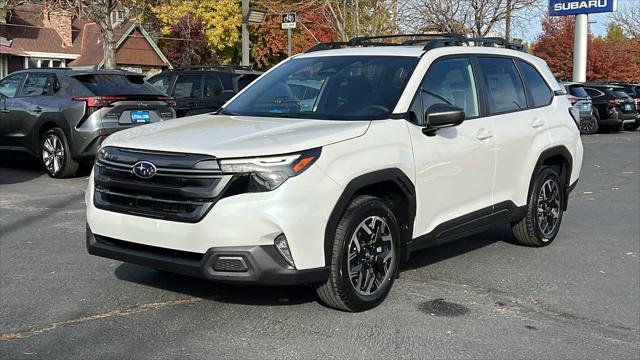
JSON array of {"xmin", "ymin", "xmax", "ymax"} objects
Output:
[{"xmin": 103, "ymin": 114, "xmax": 370, "ymax": 158}]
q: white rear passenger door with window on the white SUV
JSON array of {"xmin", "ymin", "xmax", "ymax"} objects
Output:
[{"xmin": 478, "ymin": 56, "xmax": 553, "ymax": 206}]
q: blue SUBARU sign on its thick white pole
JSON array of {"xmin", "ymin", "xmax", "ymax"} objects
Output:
[{"xmin": 549, "ymin": 0, "xmax": 618, "ymax": 82}]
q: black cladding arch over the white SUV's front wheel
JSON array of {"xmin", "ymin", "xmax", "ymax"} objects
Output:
[{"xmin": 324, "ymin": 168, "xmax": 416, "ymax": 265}]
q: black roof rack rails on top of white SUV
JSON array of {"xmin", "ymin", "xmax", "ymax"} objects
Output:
[{"xmin": 305, "ymin": 33, "xmax": 527, "ymax": 53}]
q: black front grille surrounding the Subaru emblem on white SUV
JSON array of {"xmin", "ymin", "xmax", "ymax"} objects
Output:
[{"xmin": 94, "ymin": 147, "xmax": 232, "ymax": 223}]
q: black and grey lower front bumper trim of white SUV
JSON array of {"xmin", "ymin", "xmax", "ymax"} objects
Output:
[{"xmin": 86, "ymin": 225, "xmax": 329, "ymax": 285}]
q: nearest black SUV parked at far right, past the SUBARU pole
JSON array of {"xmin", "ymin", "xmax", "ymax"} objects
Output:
[{"xmin": 584, "ymin": 83, "xmax": 637, "ymax": 131}]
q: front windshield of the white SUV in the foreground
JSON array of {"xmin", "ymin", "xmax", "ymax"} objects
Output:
[{"xmin": 223, "ymin": 56, "xmax": 419, "ymax": 120}]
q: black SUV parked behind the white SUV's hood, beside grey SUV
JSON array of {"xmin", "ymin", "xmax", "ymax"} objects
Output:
[{"xmin": 149, "ymin": 65, "xmax": 262, "ymax": 117}]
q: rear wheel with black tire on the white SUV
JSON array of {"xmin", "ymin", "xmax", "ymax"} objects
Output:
[{"xmin": 511, "ymin": 167, "xmax": 565, "ymax": 247}]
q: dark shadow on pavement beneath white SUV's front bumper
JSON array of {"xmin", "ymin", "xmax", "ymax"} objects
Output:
[{"xmin": 115, "ymin": 263, "xmax": 317, "ymax": 306}]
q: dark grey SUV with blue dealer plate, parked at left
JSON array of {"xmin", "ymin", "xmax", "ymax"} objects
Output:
[{"xmin": 0, "ymin": 68, "xmax": 175, "ymax": 178}]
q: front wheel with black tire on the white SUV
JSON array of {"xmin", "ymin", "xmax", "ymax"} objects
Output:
[{"xmin": 316, "ymin": 196, "xmax": 400, "ymax": 312}]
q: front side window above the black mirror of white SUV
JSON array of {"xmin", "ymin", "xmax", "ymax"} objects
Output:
[{"xmin": 411, "ymin": 58, "xmax": 479, "ymax": 124}]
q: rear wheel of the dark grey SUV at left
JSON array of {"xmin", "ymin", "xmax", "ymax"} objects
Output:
[{"xmin": 39, "ymin": 128, "xmax": 80, "ymax": 179}]
